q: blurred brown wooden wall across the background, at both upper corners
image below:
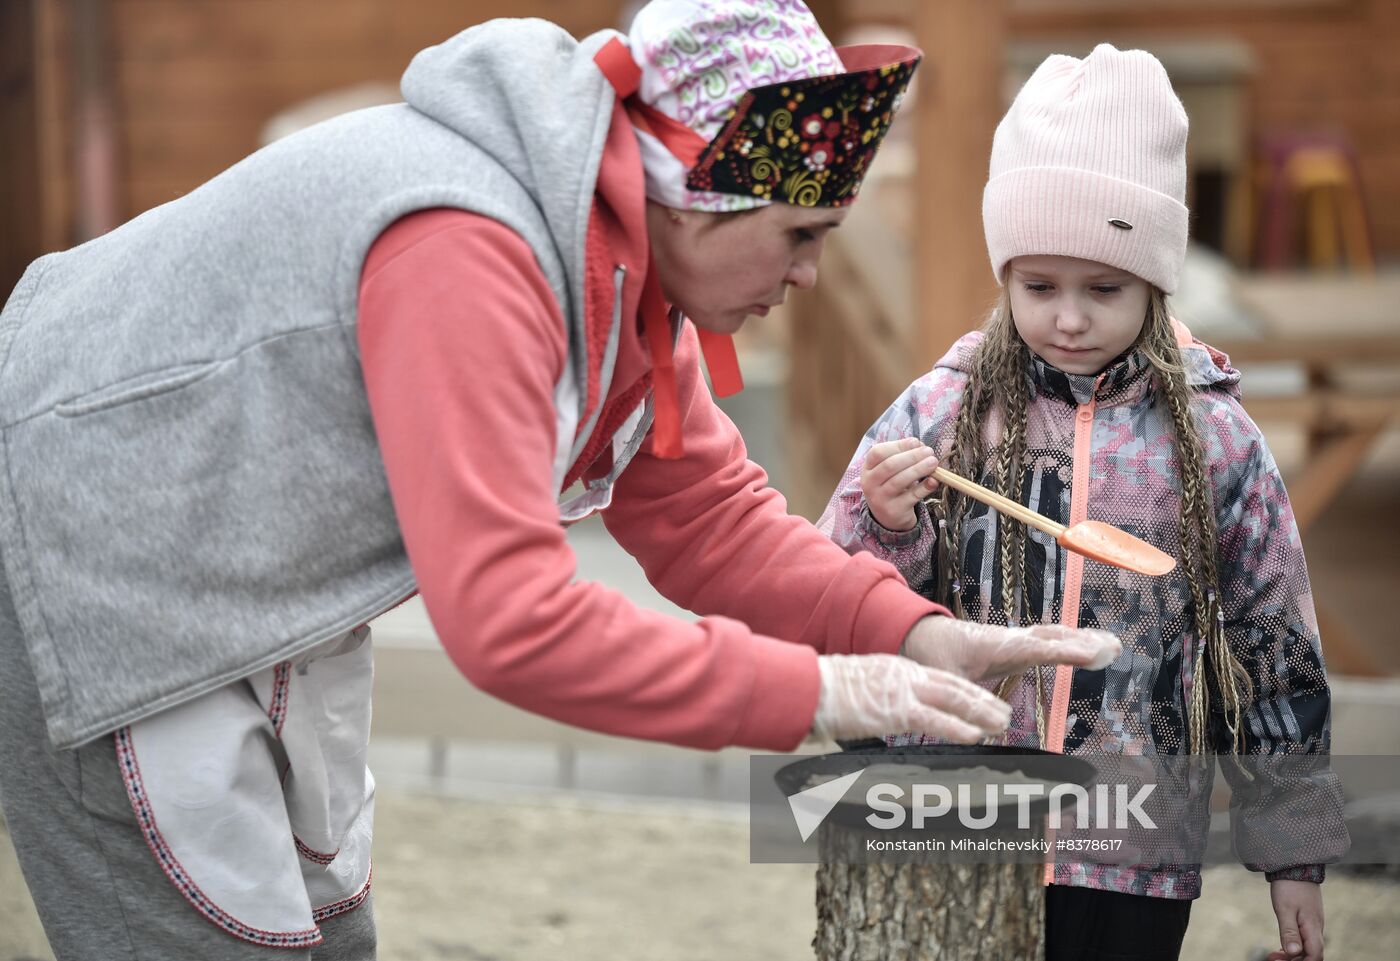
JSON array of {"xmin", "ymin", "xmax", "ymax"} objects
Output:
[{"xmin": 0, "ymin": 0, "xmax": 1400, "ymax": 291}]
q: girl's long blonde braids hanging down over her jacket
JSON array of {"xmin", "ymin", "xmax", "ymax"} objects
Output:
[{"xmin": 938, "ymin": 287, "xmax": 1253, "ymax": 754}]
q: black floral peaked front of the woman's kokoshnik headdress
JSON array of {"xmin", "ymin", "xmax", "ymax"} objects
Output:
[{"xmin": 686, "ymin": 45, "xmax": 921, "ymax": 207}]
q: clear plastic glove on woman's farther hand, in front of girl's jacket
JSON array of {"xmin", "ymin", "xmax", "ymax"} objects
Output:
[{"xmin": 900, "ymin": 618, "xmax": 1123, "ymax": 681}]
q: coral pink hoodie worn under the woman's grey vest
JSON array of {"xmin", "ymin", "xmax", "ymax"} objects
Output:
[{"xmin": 358, "ymin": 101, "xmax": 944, "ymax": 749}]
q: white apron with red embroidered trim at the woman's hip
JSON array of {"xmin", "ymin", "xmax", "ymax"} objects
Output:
[{"xmin": 116, "ymin": 626, "xmax": 374, "ymax": 947}]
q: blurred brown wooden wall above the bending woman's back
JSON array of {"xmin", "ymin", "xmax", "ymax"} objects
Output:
[{"xmin": 0, "ymin": 0, "xmax": 624, "ymax": 300}]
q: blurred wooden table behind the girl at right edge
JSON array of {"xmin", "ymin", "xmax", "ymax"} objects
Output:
[{"xmin": 1215, "ymin": 275, "xmax": 1400, "ymax": 674}]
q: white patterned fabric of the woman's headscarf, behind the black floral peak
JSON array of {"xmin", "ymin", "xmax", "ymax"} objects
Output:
[{"xmin": 627, "ymin": 0, "xmax": 846, "ymax": 212}]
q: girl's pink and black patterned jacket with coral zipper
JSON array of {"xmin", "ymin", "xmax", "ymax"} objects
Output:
[{"xmin": 819, "ymin": 328, "xmax": 1345, "ymax": 898}]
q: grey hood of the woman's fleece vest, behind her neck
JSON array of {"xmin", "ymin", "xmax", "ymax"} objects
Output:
[{"xmin": 400, "ymin": 20, "xmax": 622, "ymax": 279}]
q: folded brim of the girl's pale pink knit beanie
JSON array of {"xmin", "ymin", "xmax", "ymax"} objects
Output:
[{"xmin": 981, "ymin": 167, "xmax": 1189, "ymax": 294}]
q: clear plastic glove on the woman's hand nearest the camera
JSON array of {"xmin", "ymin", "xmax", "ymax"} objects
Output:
[{"xmin": 812, "ymin": 654, "xmax": 1011, "ymax": 744}]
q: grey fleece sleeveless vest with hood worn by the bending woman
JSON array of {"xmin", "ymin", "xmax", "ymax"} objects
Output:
[{"xmin": 0, "ymin": 21, "xmax": 630, "ymax": 747}]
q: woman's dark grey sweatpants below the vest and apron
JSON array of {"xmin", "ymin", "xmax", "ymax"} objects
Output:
[{"xmin": 0, "ymin": 560, "xmax": 375, "ymax": 961}]
